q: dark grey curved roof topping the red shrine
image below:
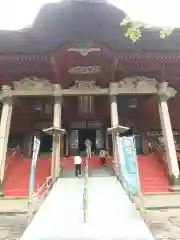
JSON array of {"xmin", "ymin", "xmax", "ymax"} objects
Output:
[{"xmin": 0, "ymin": 1, "xmax": 180, "ymax": 54}]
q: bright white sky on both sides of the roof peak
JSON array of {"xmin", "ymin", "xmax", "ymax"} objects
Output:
[{"xmin": 0, "ymin": 0, "xmax": 180, "ymax": 30}]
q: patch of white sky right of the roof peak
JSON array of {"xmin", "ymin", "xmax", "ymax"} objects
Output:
[{"xmin": 109, "ymin": 0, "xmax": 180, "ymax": 27}]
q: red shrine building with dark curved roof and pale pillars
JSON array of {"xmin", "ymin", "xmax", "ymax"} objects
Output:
[{"xmin": 0, "ymin": 0, "xmax": 180, "ymax": 196}]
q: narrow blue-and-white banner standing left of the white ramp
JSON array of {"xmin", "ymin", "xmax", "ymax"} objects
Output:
[{"xmin": 29, "ymin": 136, "xmax": 40, "ymax": 196}]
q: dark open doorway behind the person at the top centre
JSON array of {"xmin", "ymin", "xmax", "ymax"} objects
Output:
[{"xmin": 78, "ymin": 129, "xmax": 96, "ymax": 152}]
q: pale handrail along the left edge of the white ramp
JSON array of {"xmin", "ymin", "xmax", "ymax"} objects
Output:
[{"xmin": 28, "ymin": 177, "xmax": 52, "ymax": 222}]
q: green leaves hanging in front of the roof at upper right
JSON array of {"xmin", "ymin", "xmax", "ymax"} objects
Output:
[{"xmin": 121, "ymin": 17, "xmax": 173, "ymax": 42}]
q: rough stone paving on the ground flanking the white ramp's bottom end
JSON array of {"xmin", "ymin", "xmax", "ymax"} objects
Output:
[{"xmin": 0, "ymin": 209, "xmax": 180, "ymax": 240}]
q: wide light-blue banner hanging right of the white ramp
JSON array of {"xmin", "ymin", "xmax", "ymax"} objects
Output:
[{"xmin": 118, "ymin": 136, "xmax": 140, "ymax": 194}]
